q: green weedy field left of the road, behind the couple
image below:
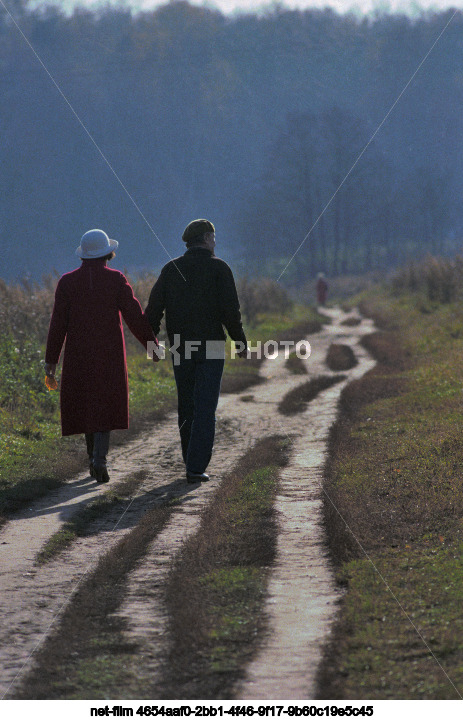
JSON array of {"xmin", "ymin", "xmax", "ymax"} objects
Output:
[{"xmin": 0, "ymin": 275, "xmax": 319, "ymax": 519}]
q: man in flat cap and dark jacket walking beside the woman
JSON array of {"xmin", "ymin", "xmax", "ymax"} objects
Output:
[{"xmin": 145, "ymin": 219, "xmax": 247, "ymax": 483}]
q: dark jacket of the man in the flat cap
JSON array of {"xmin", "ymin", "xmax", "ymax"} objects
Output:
[{"xmin": 145, "ymin": 247, "xmax": 246, "ymax": 349}]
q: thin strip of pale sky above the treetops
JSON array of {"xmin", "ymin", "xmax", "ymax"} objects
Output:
[{"xmin": 31, "ymin": 0, "xmax": 463, "ymax": 16}]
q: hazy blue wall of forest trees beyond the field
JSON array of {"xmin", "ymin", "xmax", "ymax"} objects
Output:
[{"xmin": 0, "ymin": 0, "xmax": 463, "ymax": 283}]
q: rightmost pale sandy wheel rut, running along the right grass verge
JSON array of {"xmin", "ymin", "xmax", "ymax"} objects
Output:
[{"xmin": 235, "ymin": 310, "xmax": 374, "ymax": 700}]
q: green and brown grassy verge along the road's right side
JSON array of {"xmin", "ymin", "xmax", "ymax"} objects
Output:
[{"xmin": 319, "ymin": 278, "xmax": 463, "ymax": 699}]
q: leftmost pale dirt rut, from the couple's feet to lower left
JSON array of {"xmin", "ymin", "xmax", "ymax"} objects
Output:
[{"xmin": 0, "ymin": 418, "xmax": 188, "ymax": 697}]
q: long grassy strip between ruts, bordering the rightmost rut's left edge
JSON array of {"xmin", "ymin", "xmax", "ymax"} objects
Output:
[{"xmin": 162, "ymin": 437, "xmax": 288, "ymax": 698}]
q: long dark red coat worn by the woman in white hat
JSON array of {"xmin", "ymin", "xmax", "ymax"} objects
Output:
[{"xmin": 45, "ymin": 258, "xmax": 155, "ymax": 436}]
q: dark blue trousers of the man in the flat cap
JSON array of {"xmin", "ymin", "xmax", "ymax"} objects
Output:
[{"xmin": 174, "ymin": 358, "xmax": 224, "ymax": 473}]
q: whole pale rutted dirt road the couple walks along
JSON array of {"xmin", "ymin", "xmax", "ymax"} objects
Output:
[{"xmin": 0, "ymin": 309, "xmax": 373, "ymax": 699}]
